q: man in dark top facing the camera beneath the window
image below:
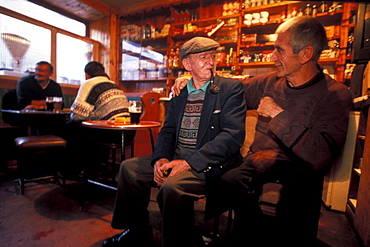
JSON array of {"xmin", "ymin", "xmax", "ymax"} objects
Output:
[{"xmin": 16, "ymin": 61, "xmax": 63, "ymax": 109}]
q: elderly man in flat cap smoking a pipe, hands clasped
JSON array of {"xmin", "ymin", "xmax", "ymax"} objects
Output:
[{"xmin": 103, "ymin": 37, "xmax": 246, "ymax": 247}]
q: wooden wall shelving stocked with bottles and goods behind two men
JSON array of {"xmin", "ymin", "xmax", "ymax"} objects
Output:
[{"xmin": 121, "ymin": 0, "xmax": 357, "ymax": 93}]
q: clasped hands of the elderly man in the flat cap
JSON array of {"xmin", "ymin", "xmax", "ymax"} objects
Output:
[{"xmin": 154, "ymin": 159, "xmax": 191, "ymax": 186}]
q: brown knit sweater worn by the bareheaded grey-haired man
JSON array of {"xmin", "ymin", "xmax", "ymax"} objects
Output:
[{"xmin": 244, "ymin": 72, "xmax": 352, "ymax": 172}]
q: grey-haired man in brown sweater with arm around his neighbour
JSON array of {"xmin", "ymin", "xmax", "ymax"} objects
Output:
[{"xmin": 173, "ymin": 17, "xmax": 352, "ymax": 247}]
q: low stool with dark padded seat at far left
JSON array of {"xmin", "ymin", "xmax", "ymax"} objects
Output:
[{"xmin": 14, "ymin": 135, "xmax": 66, "ymax": 195}]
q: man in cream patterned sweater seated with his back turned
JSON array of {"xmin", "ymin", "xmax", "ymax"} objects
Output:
[{"xmin": 65, "ymin": 61, "xmax": 136, "ymax": 177}]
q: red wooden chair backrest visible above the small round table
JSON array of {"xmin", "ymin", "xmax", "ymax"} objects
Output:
[{"xmin": 140, "ymin": 92, "xmax": 161, "ymax": 122}]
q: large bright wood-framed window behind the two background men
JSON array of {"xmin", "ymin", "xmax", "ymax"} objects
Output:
[{"xmin": 0, "ymin": 0, "xmax": 97, "ymax": 85}]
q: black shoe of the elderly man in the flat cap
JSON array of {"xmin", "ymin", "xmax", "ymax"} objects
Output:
[{"xmin": 103, "ymin": 227, "xmax": 153, "ymax": 247}]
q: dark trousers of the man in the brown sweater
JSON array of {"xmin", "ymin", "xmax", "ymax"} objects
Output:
[{"xmin": 222, "ymin": 159, "xmax": 323, "ymax": 247}]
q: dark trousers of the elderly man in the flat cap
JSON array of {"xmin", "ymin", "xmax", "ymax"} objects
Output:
[{"xmin": 112, "ymin": 156, "xmax": 205, "ymax": 247}]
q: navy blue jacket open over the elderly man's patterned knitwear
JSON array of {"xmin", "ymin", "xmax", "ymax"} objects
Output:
[{"xmin": 152, "ymin": 76, "xmax": 246, "ymax": 179}]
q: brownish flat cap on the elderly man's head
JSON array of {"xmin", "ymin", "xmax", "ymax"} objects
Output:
[{"xmin": 180, "ymin": 37, "xmax": 220, "ymax": 60}]
